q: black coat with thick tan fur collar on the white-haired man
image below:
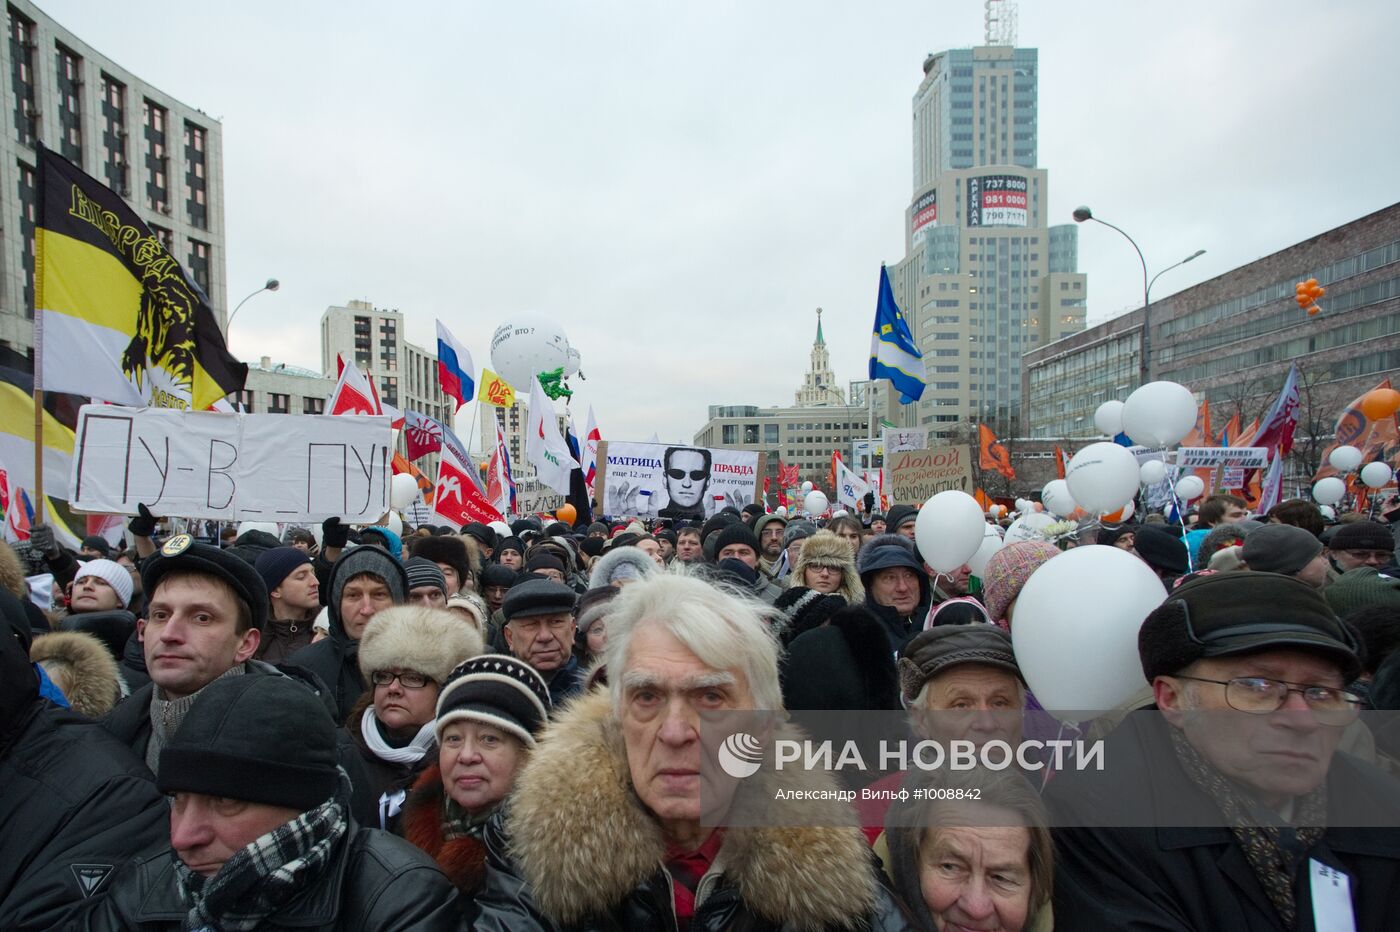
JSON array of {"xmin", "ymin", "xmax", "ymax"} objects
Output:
[{"xmin": 469, "ymin": 691, "xmax": 911, "ymax": 932}]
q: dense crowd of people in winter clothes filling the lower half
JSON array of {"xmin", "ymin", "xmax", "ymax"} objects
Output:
[{"xmin": 0, "ymin": 495, "xmax": 1400, "ymax": 932}]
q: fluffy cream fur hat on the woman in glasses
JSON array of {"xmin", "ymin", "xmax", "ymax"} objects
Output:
[{"xmin": 358, "ymin": 605, "xmax": 483, "ymax": 683}]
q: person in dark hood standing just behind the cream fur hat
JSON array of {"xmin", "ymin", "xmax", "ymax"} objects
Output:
[{"xmin": 290, "ymin": 546, "xmax": 409, "ymax": 722}]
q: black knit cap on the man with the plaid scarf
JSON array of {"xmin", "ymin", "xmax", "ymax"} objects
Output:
[{"xmin": 155, "ymin": 673, "xmax": 340, "ymax": 812}]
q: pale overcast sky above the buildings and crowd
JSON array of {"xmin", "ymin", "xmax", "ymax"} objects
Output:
[{"xmin": 41, "ymin": 0, "xmax": 1400, "ymax": 441}]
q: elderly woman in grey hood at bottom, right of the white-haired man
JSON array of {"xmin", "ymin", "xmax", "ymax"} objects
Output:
[{"xmin": 885, "ymin": 768, "xmax": 1052, "ymax": 932}]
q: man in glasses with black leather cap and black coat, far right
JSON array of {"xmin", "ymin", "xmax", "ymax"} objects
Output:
[{"xmin": 1046, "ymin": 572, "xmax": 1400, "ymax": 932}]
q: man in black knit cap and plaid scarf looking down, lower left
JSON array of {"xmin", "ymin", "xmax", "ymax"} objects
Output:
[{"xmin": 83, "ymin": 676, "xmax": 461, "ymax": 932}]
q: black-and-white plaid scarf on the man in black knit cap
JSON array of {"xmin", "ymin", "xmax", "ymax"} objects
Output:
[{"xmin": 175, "ymin": 770, "xmax": 350, "ymax": 932}]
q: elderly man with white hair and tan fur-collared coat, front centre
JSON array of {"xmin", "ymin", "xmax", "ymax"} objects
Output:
[{"xmin": 469, "ymin": 572, "xmax": 907, "ymax": 931}]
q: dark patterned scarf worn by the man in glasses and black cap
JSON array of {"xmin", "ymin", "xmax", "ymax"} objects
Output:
[{"xmin": 1168, "ymin": 728, "xmax": 1327, "ymax": 929}]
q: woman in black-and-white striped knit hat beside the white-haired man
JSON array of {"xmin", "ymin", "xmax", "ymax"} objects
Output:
[{"xmin": 398, "ymin": 654, "xmax": 548, "ymax": 896}]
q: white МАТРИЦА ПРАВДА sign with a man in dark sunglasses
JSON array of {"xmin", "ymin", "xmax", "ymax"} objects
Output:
[{"xmin": 594, "ymin": 441, "xmax": 766, "ymax": 521}]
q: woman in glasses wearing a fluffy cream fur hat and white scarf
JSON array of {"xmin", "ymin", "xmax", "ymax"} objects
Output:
[{"xmin": 344, "ymin": 606, "xmax": 482, "ymax": 828}]
